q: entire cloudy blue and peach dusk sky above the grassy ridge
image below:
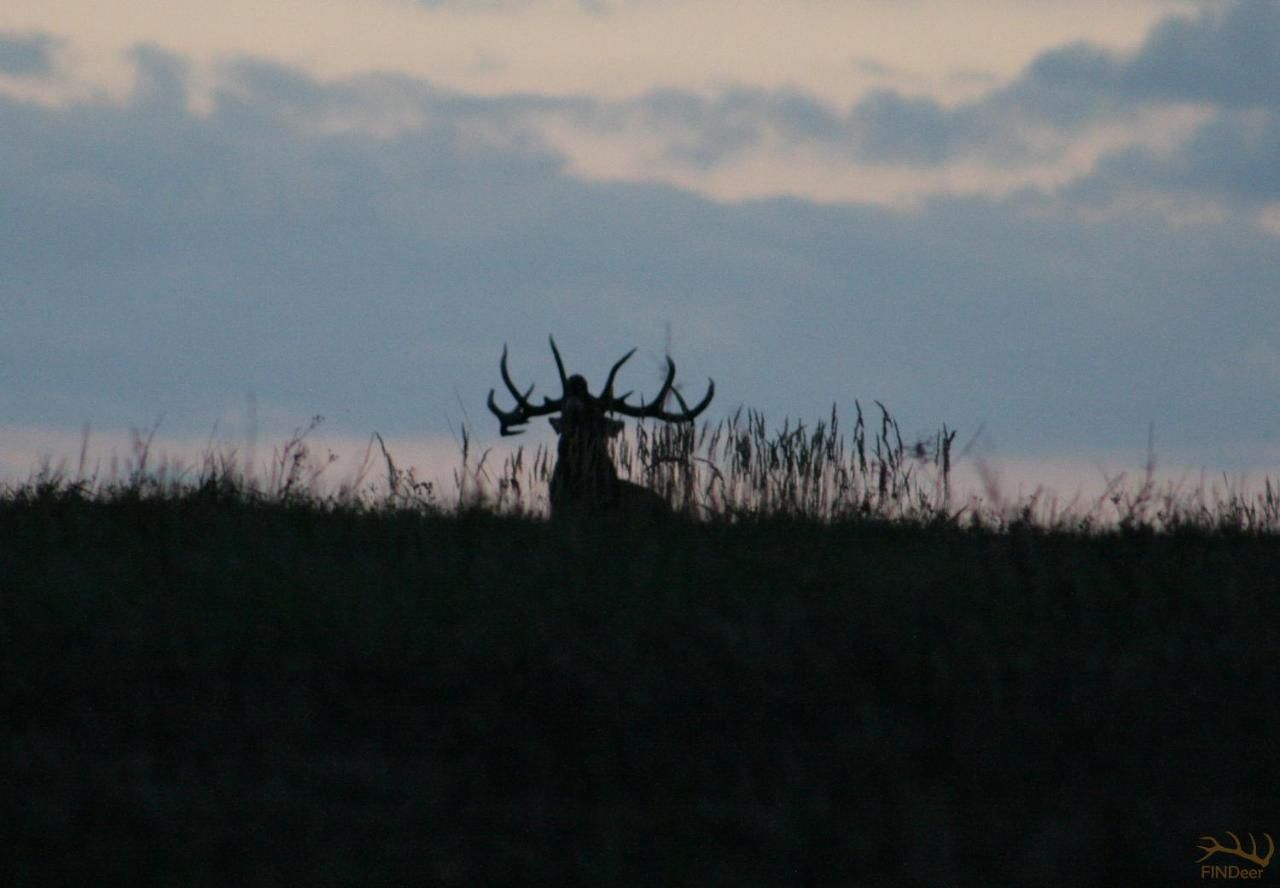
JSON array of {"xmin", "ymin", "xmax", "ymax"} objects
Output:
[{"xmin": 0, "ymin": 0, "xmax": 1280, "ymax": 496}]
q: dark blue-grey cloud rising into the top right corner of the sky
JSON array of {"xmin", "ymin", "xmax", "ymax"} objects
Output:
[{"xmin": 819, "ymin": 0, "xmax": 1280, "ymax": 168}]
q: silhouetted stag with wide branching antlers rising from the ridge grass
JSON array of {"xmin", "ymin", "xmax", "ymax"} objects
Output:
[{"xmin": 489, "ymin": 338, "xmax": 716, "ymax": 518}]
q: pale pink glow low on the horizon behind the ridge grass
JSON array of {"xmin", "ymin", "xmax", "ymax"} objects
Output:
[{"xmin": 0, "ymin": 429, "xmax": 1280, "ymax": 523}]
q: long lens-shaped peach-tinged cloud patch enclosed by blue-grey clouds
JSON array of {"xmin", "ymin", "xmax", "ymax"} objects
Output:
[{"xmin": 463, "ymin": 68, "xmax": 1212, "ymax": 206}]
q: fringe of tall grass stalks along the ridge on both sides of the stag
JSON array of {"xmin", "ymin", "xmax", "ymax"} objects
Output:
[{"xmin": 10, "ymin": 402, "xmax": 1280, "ymax": 534}]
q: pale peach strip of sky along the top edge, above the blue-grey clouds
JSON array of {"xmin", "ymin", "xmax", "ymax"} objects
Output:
[{"xmin": 0, "ymin": 0, "xmax": 1187, "ymax": 105}]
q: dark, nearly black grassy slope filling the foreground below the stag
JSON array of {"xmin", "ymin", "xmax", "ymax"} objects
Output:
[{"xmin": 0, "ymin": 496, "xmax": 1280, "ymax": 885}]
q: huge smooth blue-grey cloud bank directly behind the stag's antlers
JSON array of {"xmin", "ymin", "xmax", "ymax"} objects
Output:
[{"xmin": 0, "ymin": 47, "xmax": 1280, "ymax": 473}]
